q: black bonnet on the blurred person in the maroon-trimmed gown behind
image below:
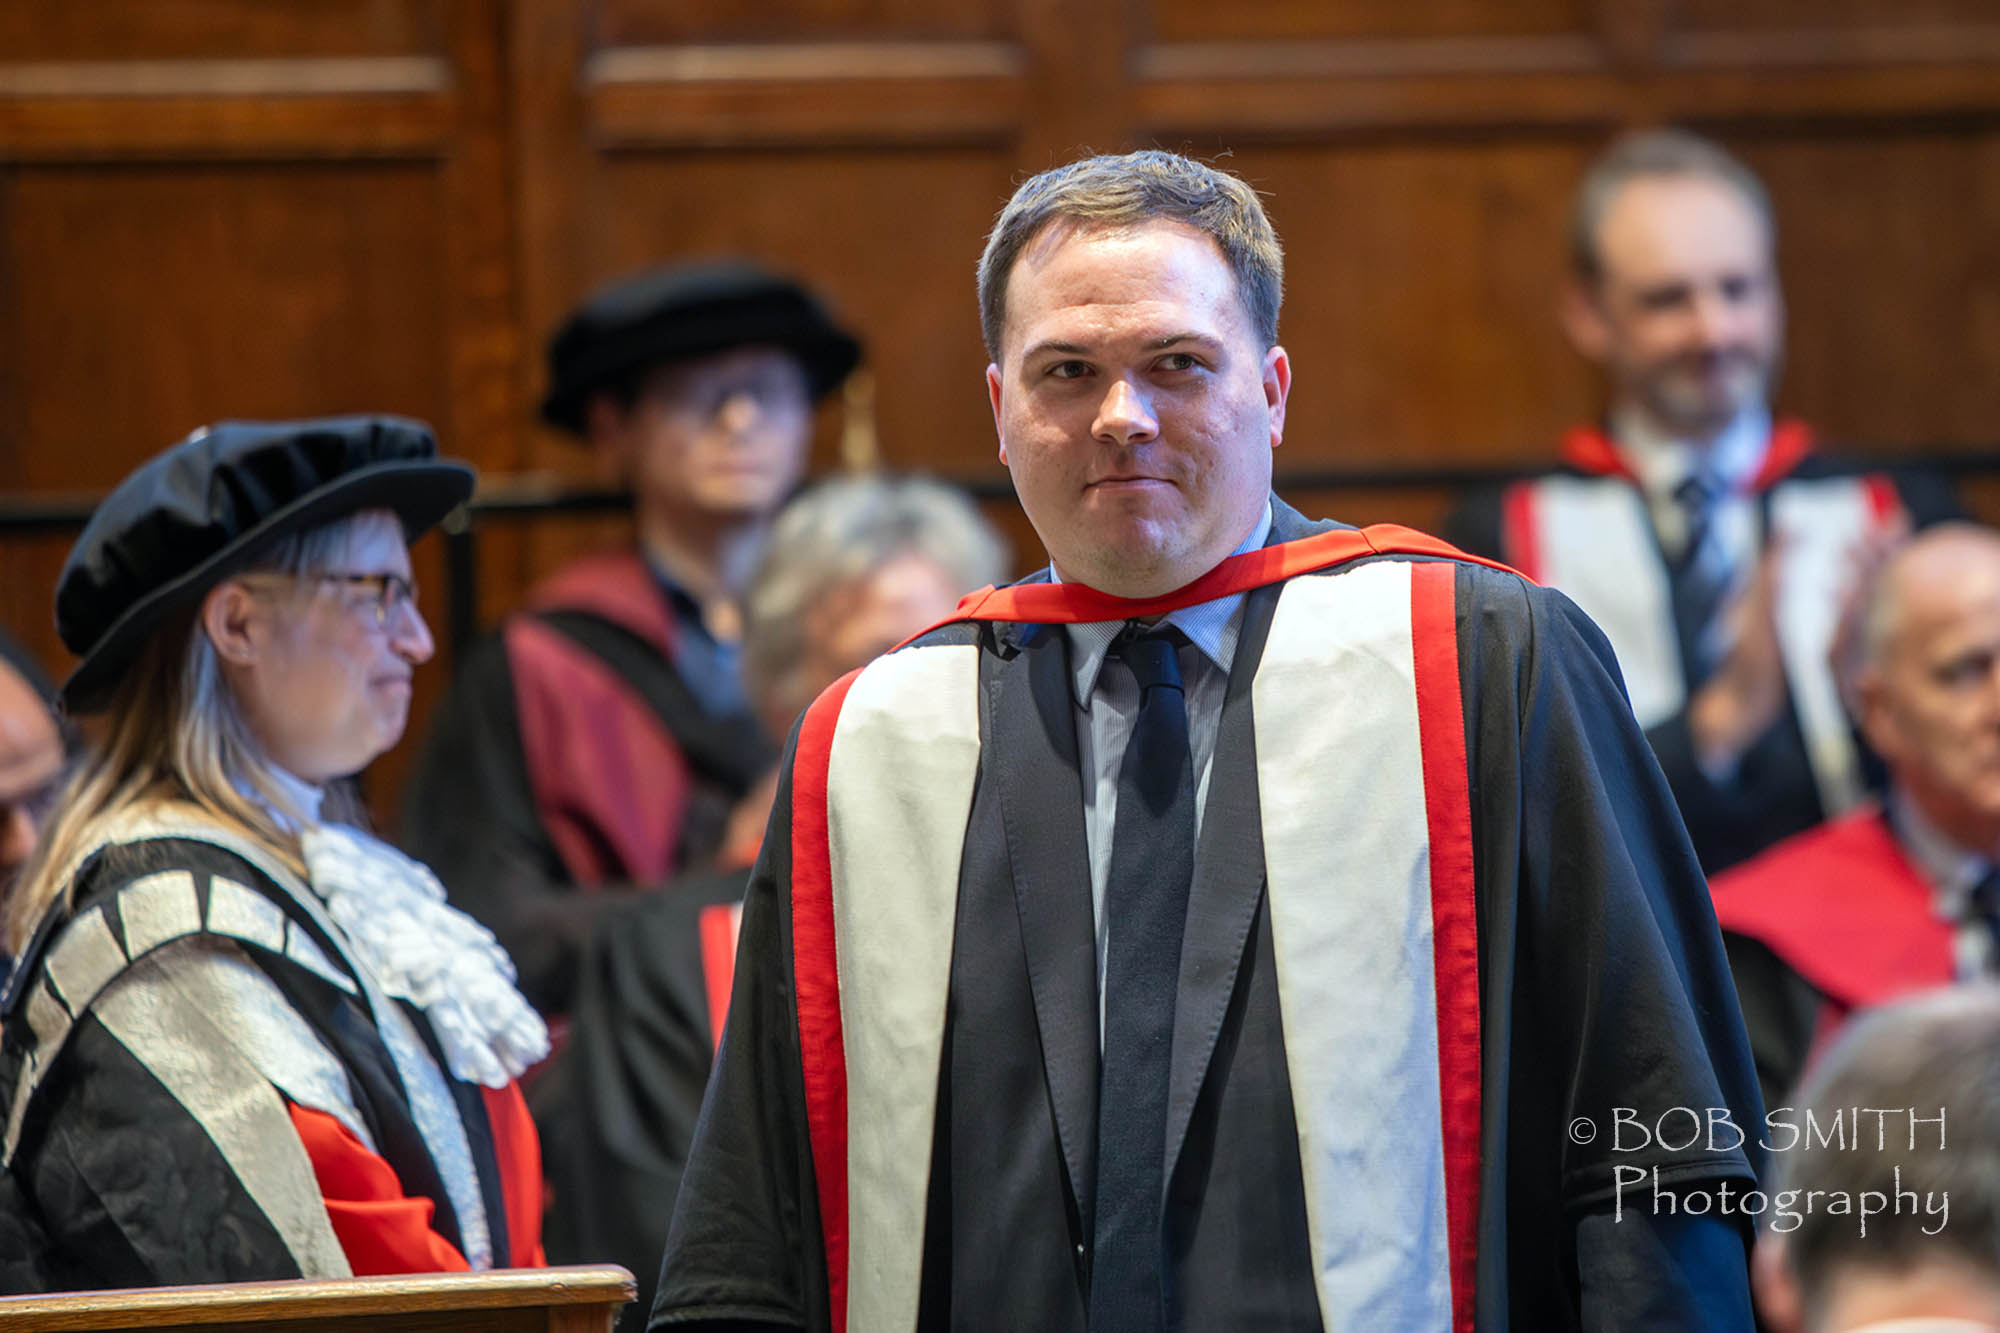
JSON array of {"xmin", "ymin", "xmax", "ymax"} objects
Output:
[{"xmin": 542, "ymin": 260, "xmax": 862, "ymax": 434}]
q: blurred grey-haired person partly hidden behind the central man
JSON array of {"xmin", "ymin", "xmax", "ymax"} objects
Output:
[{"xmin": 534, "ymin": 476, "xmax": 1008, "ymax": 1327}]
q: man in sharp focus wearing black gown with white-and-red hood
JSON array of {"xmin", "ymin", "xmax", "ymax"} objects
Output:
[{"xmin": 652, "ymin": 152, "xmax": 1758, "ymax": 1331}]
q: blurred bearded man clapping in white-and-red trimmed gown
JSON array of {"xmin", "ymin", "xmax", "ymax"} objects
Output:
[{"xmin": 1448, "ymin": 130, "xmax": 1956, "ymax": 875}]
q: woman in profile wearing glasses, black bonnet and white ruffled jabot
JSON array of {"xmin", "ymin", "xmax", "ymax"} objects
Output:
[{"xmin": 0, "ymin": 416, "xmax": 548, "ymax": 1291}]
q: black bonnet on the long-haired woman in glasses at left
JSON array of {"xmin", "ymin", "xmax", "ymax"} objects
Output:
[{"xmin": 56, "ymin": 416, "xmax": 474, "ymax": 715}]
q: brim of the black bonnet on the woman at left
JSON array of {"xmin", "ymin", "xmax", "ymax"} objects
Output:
[{"xmin": 62, "ymin": 458, "xmax": 474, "ymax": 717}]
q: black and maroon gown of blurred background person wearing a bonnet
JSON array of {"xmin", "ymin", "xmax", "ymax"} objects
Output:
[{"xmin": 400, "ymin": 552, "xmax": 774, "ymax": 1016}]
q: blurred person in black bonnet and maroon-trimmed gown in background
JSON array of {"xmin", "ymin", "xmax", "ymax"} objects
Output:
[{"xmin": 402, "ymin": 264, "xmax": 860, "ymax": 1015}]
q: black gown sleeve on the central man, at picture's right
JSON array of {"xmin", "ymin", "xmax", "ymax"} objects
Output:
[{"xmin": 1458, "ymin": 566, "xmax": 1762, "ymax": 1329}]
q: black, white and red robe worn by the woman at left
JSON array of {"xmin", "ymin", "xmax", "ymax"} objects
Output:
[{"xmin": 0, "ymin": 807, "xmax": 544, "ymax": 1295}]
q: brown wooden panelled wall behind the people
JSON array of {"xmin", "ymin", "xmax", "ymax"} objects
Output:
[{"xmin": 0, "ymin": 0, "xmax": 2000, "ymax": 805}]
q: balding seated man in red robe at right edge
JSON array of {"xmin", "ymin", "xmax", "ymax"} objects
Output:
[{"xmin": 1712, "ymin": 522, "xmax": 2000, "ymax": 1107}]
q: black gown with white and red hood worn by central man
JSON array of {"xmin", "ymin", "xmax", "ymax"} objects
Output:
[{"xmin": 652, "ymin": 502, "xmax": 1760, "ymax": 1333}]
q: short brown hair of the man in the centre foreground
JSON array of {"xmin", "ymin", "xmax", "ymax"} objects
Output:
[{"xmin": 980, "ymin": 148, "xmax": 1284, "ymax": 360}]
